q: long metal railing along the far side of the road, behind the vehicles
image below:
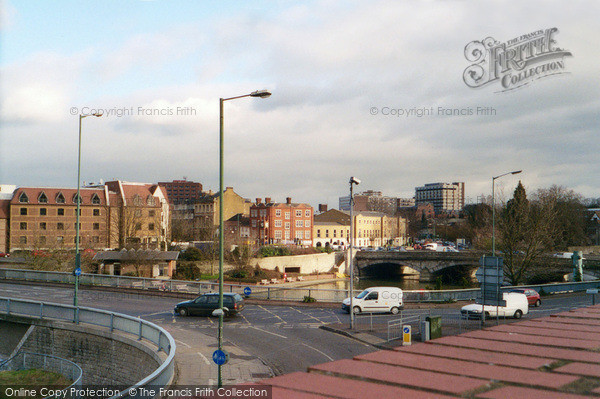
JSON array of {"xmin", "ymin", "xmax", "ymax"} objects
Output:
[{"xmin": 0, "ymin": 269, "xmax": 600, "ymax": 302}]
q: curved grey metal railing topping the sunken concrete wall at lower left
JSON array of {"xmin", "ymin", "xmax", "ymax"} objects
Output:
[{"xmin": 0, "ymin": 297, "xmax": 176, "ymax": 398}]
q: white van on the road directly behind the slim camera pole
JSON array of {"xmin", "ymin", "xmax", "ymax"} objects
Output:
[{"xmin": 342, "ymin": 287, "xmax": 404, "ymax": 314}]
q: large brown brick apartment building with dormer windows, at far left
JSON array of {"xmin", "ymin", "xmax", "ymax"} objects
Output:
[{"xmin": 5, "ymin": 181, "xmax": 170, "ymax": 251}]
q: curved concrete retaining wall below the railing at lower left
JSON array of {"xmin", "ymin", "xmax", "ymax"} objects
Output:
[{"xmin": 4, "ymin": 316, "xmax": 160, "ymax": 386}]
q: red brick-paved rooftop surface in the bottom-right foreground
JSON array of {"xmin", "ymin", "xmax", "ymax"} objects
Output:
[{"xmin": 259, "ymin": 305, "xmax": 600, "ymax": 399}]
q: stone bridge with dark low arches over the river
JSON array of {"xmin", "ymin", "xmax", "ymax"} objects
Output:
[{"xmin": 354, "ymin": 251, "xmax": 584, "ymax": 282}]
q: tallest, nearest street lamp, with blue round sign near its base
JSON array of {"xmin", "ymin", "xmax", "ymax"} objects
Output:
[{"xmin": 217, "ymin": 90, "xmax": 271, "ymax": 387}]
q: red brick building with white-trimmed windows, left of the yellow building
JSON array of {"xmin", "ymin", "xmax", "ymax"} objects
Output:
[{"xmin": 250, "ymin": 197, "xmax": 314, "ymax": 246}]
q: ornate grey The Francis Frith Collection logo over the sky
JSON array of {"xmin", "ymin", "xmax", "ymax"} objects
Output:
[{"xmin": 463, "ymin": 28, "xmax": 572, "ymax": 92}]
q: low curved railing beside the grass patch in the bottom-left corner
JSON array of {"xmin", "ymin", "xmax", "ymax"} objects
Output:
[{"xmin": 0, "ymin": 352, "xmax": 83, "ymax": 399}]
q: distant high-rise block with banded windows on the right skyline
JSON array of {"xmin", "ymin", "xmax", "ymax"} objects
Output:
[{"xmin": 415, "ymin": 182, "xmax": 465, "ymax": 215}]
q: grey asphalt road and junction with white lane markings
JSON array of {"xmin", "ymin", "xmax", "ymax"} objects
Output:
[{"xmin": 0, "ymin": 283, "xmax": 591, "ymax": 374}]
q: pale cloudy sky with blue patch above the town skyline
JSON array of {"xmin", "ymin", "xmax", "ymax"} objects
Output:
[{"xmin": 0, "ymin": 0, "xmax": 600, "ymax": 207}]
